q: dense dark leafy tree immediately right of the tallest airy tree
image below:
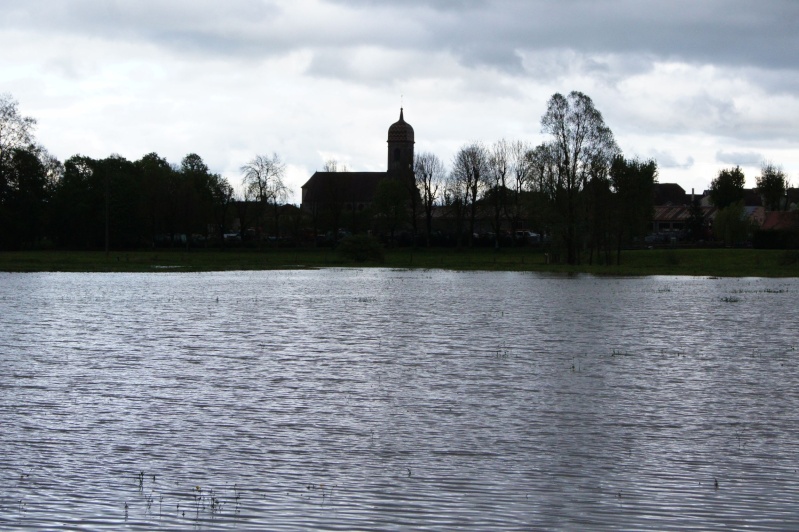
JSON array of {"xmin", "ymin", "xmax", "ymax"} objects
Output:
[{"xmin": 610, "ymin": 155, "xmax": 658, "ymax": 264}]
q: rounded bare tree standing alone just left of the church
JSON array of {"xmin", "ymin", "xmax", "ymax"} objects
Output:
[{"xmin": 241, "ymin": 153, "xmax": 291, "ymax": 241}]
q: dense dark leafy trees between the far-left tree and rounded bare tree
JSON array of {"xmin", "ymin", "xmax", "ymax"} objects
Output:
[{"xmin": 47, "ymin": 153, "xmax": 233, "ymax": 248}]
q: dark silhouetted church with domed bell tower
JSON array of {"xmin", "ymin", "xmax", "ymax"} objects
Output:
[{"xmin": 301, "ymin": 109, "xmax": 414, "ymax": 217}]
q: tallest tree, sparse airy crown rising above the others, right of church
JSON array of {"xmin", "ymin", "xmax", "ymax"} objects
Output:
[{"xmin": 541, "ymin": 91, "xmax": 618, "ymax": 264}]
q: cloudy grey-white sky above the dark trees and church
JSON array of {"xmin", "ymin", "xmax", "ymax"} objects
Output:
[{"xmin": 0, "ymin": 0, "xmax": 799, "ymax": 203}]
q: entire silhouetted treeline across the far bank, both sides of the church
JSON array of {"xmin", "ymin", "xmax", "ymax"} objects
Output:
[{"xmin": 0, "ymin": 92, "xmax": 791, "ymax": 258}]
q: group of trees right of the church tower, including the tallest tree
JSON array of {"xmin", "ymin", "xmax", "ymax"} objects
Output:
[{"xmin": 414, "ymin": 91, "xmax": 657, "ymax": 264}]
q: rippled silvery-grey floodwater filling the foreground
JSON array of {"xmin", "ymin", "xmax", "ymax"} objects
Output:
[{"xmin": 0, "ymin": 269, "xmax": 799, "ymax": 530}]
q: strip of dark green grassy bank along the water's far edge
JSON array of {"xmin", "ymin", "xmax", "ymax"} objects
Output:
[{"xmin": 0, "ymin": 248, "xmax": 799, "ymax": 277}]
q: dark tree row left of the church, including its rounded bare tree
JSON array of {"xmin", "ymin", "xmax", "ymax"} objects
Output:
[{"xmin": 0, "ymin": 94, "xmax": 289, "ymax": 250}]
